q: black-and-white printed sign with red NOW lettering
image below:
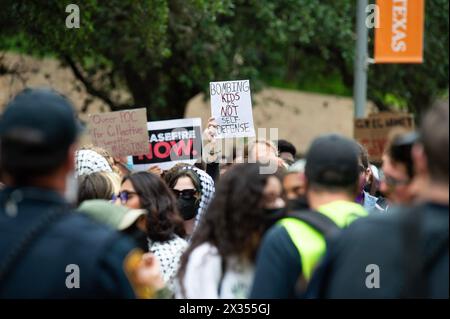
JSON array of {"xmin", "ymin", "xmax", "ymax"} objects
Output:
[{"xmin": 133, "ymin": 118, "xmax": 202, "ymax": 171}]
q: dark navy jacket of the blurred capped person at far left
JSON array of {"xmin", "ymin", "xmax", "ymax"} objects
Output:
[{"xmin": 0, "ymin": 188, "xmax": 135, "ymax": 298}]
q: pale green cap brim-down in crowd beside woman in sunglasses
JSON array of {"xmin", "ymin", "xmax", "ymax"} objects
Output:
[{"xmin": 78, "ymin": 199, "xmax": 146, "ymax": 230}]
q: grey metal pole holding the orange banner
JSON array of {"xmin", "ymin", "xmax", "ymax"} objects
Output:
[{"xmin": 353, "ymin": 0, "xmax": 368, "ymax": 118}]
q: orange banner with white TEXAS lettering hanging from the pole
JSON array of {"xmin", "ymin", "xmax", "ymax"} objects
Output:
[{"xmin": 375, "ymin": 0, "xmax": 425, "ymax": 63}]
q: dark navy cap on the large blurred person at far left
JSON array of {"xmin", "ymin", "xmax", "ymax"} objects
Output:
[{"xmin": 0, "ymin": 88, "xmax": 82, "ymax": 154}]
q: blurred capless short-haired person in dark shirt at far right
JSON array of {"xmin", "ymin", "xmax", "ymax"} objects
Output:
[{"xmin": 308, "ymin": 101, "xmax": 449, "ymax": 299}]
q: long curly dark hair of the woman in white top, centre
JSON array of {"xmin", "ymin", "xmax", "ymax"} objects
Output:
[{"xmin": 178, "ymin": 163, "xmax": 275, "ymax": 291}]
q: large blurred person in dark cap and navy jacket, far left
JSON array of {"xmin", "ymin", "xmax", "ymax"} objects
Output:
[{"xmin": 0, "ymin": 89, "xmax": 164, "ymax": 298}]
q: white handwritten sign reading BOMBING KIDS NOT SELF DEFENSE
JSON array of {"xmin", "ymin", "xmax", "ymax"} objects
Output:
[{"xmin": 209, "ymin": 80, "xmax": 255, "ymax": 138}]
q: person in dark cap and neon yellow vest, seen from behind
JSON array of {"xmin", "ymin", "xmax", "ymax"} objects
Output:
[{"xmin": 250, "ymin": 134, "xmax": 367, "ymax": 299}]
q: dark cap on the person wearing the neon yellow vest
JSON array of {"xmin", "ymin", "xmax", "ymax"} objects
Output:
[{"xmin": 305, "ymin": 134, "xmax": 359, "ymax": 187}]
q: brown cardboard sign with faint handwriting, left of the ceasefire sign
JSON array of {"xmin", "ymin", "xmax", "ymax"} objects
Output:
[{"xmin": 89, "ymin": 108, "xmax": 148, "ymax": 156}]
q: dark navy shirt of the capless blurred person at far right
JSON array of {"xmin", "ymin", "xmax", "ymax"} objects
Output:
[{"xmin": 307, "ymin": 203, "xmax": 449, "ymax": 298}]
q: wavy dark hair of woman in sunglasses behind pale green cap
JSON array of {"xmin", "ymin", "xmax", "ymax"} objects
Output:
[{"xmin": 122, "ymin": 172, "xmax": 186, "ymax": 242}]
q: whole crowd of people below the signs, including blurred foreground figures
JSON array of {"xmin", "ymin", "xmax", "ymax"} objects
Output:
[{"xmin": 0, "ymin": 89, "xmax": 449, "ymax": 299}]
